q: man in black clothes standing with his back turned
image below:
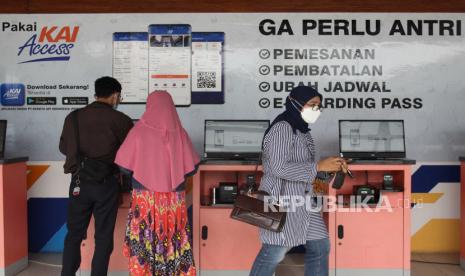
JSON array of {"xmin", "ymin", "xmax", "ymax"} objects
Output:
[{"xmin": 60, "ymin": 77, "xmax": 133, "ymax": 276}]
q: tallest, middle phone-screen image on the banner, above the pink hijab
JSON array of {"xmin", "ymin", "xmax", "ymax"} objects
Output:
[{"xmin": 149, "ymin": 24, "xmax": 192, "ymax": 106}]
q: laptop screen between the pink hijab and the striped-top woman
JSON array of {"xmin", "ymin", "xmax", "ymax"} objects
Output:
[{"xmin": 204, "ymin": 120, "xmax": 270, "ymax": 160}]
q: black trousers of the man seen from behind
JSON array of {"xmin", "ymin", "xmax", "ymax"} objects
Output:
[{"xmin": 61, "ymin": 176, "xmax": 119, "ymax": 276}]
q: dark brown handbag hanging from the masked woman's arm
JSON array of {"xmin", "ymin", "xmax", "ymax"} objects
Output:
[{"xmin": 231, "ymin": 155, "xmax": 287, "ymax": 232}]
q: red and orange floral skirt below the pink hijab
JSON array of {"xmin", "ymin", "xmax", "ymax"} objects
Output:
[{"xmin": 123, "ymin": 189, "xmax": 195, "ymax": 276}]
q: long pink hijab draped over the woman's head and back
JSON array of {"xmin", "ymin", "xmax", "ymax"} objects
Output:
[{"xmin": 115, "ymin": 91, "xmax": 199, "ymax": 192}]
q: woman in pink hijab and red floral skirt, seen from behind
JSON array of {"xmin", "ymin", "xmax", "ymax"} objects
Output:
[{"xmin": 115, "ymin": 91, "xmax": 199, "ymax": 276}]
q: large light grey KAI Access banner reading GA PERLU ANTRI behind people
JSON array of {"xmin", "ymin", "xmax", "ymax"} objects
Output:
[{"xmin": 0, "ymin": 13, "xmax": 465, "ymax": 161}]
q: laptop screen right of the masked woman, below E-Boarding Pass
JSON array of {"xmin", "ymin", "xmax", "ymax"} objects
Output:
[{"xmin": 339, "ymin": 120, "xmax": 405, "ymax": 159}]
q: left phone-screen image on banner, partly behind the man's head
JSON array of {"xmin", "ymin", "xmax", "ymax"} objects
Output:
[{"xmin": 113, "ymin": 32, "xmax": 148, "ymax": 104}]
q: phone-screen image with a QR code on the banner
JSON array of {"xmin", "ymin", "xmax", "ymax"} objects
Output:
[{"xmin": 192, "ymin": 32, "xmax": 224, "ymax": 104}]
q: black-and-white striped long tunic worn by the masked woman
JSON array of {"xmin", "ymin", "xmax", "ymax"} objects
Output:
[{"xmin": 260, "ymin": 121, "xmax": 328, "ymax": 247}]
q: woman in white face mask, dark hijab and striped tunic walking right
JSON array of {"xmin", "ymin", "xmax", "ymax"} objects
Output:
[{"xmin": 250, "ymin": 86, "xmax": 347, "ymax": 276}]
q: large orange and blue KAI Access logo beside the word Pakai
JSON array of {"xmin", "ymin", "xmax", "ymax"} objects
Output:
[{"xmin": 18, "ymin": 26, "xmax": 79, "ymax": 63}]
